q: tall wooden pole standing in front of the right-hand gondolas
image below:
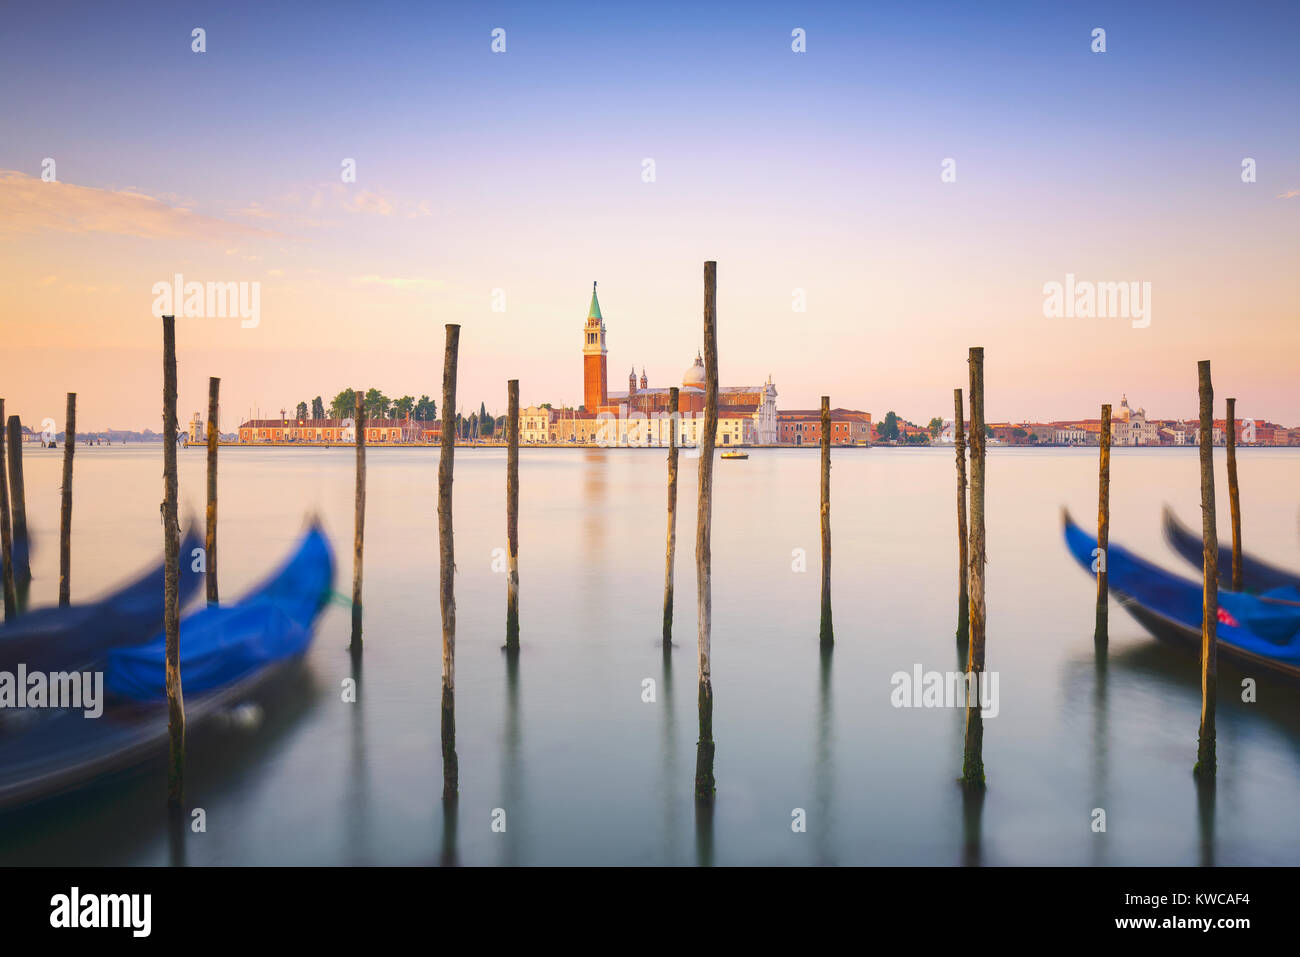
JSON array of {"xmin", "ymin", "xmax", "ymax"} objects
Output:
[{"xmin": 1195, "ymin": 359, "xmax": 1218, "ymax": 779}]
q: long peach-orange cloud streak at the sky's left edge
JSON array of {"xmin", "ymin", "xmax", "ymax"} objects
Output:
[{"xmin": 0, "ymin": 169, "xmax": 278, "ymax": 241}]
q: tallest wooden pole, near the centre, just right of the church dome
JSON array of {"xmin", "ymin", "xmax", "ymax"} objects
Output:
[{"xmin": 696, "ymin": 260, "xmax": 718, "ymax": 802}]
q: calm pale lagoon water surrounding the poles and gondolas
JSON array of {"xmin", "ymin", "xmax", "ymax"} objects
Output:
[{"xmin": 0, "ymin": 446, "xmax": 1300, "ymax": 865}]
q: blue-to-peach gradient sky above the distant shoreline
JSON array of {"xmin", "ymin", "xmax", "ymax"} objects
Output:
[{"xmin": 0, "ymin": 3, "xmax": 1300, "ymax": 430}]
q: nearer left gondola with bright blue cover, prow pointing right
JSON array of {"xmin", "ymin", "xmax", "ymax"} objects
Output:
[{"xmin": 0, "ymin": 524, "xmax": 334, "ymax": 807}]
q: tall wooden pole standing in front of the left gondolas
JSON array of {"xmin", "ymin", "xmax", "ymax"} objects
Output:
[{"xmin": 161, "ymin": 316, "xmax": 185, "ymax": 807}]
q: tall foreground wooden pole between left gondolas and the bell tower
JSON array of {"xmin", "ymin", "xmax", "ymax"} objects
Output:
[{"xmin": 438, "ymin": 322, "xmax": 460, "ymax": 801}]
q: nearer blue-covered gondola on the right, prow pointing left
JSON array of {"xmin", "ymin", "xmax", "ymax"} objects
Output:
[{"xmin": 1062, "ymin": 514, "xmax": 1300, "ymax": 679}]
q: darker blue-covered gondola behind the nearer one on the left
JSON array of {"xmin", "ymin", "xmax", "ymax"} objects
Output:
[{"xmin": 0, "ymin": 528, "xmax": 203, "ymax": 672}]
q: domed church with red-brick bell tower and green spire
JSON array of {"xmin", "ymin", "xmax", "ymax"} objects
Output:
[{"xmin": 582, "ymin": 282, "xmax": 779, "ymax": 445}]
